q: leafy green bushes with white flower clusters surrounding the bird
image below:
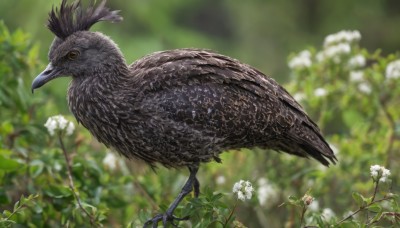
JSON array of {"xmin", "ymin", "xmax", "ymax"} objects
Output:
[{"xmin": 0, "ymin": 0, "xmax": 400, "ymax": 227}]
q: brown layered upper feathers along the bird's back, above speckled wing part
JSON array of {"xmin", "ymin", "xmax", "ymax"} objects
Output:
[{"xmin": 130, "ymin": 49, "xmax": 310, "ymax": 122}]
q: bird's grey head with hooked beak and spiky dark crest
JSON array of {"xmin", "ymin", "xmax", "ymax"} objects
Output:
[{"xmin": 32, "ymin": 0, "xmax": 122, "ymax": 92}]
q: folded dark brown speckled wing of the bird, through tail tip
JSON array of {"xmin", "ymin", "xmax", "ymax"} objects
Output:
[{"xmin": 126, "ymin": 49, "xmax": 334, "ymax": 165}]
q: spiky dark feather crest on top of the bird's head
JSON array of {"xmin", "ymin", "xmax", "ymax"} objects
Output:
[{"xmin": 47, "ymin": 0, "xmax": 122, "ymax": 39}]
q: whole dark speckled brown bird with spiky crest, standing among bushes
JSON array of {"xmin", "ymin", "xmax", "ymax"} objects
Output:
[{"xmin": 31, "ymin": 0, "xmax": 337, "ymax": 227}]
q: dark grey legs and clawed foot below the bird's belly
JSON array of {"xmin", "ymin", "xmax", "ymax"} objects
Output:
[{"xmin": 143, "ymin": 166, "xmax": 200, "ymax": 227}]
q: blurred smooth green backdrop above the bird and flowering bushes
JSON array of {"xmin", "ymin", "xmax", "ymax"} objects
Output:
[{"xmin": 0, "ymin": 0, "xmax": 400, "ymax": 78}]
